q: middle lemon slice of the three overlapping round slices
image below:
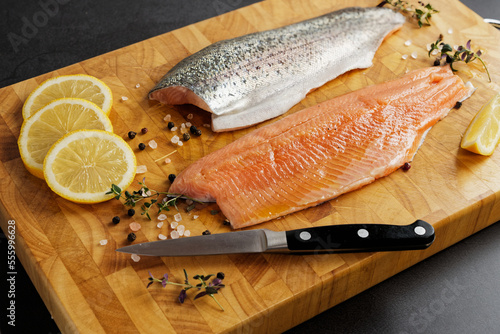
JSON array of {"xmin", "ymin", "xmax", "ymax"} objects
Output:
[{"xmin": 18, "ymin": 98, "xmax": 113, "ymax": 179}]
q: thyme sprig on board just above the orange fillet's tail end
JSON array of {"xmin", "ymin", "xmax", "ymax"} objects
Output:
[{"xmin": 428, "ymin": 35, "xmax": 491, "ymax": 82}]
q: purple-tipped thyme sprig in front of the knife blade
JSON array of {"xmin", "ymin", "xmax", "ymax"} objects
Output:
[{"xmin": 147, "ymin": 269, "xmax": 224, "ymax": 311}]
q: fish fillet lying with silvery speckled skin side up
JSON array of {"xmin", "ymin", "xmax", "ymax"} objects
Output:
[{"xmin": 149, "ymin": 7, "xmax": 405, "ymax": 132}]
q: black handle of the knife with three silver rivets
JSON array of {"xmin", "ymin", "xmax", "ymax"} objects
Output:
[{"xmin": 286, "ymin": 220, "xmax": 435, "ymax": 252}]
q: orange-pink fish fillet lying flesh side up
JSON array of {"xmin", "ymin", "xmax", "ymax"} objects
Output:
[{"xmin": 169, "ymin": 66, "xmax": 473, "ymax": 228}]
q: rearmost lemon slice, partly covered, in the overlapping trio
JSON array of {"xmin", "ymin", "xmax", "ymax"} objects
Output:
[{"xmin": 23, "ymin": 74, "xmax": 113, "ymax": 119}]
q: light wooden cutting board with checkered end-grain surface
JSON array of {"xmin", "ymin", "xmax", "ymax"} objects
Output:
[{"xmin": 0, "ymin": 0, "xmax": 500, "ymax": 333}]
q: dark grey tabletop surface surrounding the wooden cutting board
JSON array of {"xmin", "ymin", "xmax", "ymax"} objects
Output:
[{"xmin": 0, "ymin": 0, "xmax": 500, "ymax": 334}]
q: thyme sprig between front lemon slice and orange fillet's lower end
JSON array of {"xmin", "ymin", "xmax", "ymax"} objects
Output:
[{"xmin": 106, "ymin": 178, "xmax": 199, "ymax": 220}]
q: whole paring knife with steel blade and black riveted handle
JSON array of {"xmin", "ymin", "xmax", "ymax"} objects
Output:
[{"xmin": 117, "ymin": 220, "xmax": 434, "ymax": 256}]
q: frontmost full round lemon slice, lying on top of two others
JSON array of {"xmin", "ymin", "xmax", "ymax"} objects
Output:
[{"xmin": 43, "ymin": 130, "xmax": 136, "ymax": 203}]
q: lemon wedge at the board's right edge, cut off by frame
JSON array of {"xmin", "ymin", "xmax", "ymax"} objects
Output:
[{"xmin": 460, "ymin": 93, "xmax": 500, "ymax": 155}]
